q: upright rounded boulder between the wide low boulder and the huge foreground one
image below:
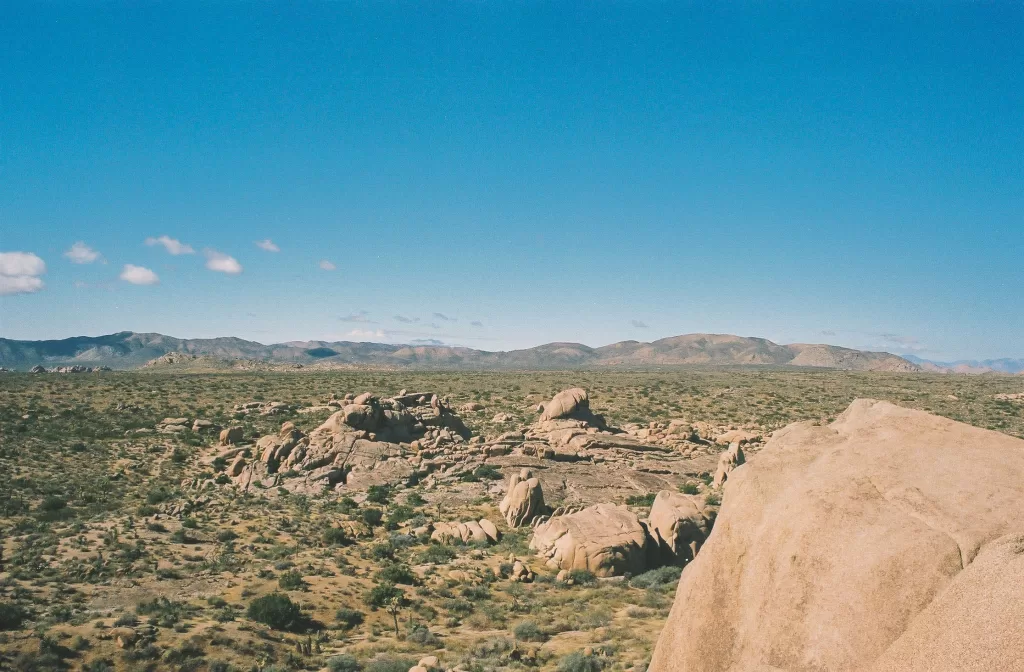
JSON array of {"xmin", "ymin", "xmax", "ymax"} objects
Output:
[{"xmin": 648, "ymin": 490, "xmax": 717, "ymax": 564}]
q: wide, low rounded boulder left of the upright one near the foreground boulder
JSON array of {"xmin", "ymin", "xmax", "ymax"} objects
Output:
[{"xmin": 529, "ymin": 504, "xmax": 647, "ymax": 577}]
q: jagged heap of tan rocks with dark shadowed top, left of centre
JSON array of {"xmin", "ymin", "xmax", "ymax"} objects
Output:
[{"xmin": 214, "ymin": 390, "xmax": 478, "ymax": 494}]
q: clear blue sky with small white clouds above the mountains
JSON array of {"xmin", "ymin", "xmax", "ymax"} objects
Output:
[{"xmin": 0, "ymin": 2, "xmax": 1024, "ymax": 359}]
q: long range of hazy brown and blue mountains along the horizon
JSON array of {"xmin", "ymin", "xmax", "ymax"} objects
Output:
[{"xmin": 0, "ymin": 332, "xmax": 921, "ymax": 372}]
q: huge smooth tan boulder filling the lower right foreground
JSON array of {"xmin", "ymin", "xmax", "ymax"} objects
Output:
[{"xmin": 649, "ymin": 400, "xmax": 1024, "ymax": 672}]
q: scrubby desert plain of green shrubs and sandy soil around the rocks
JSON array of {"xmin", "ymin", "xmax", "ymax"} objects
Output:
[{"xmin": 0, "ymin": 368, "xmax": 1024, "ymax": 672}]
